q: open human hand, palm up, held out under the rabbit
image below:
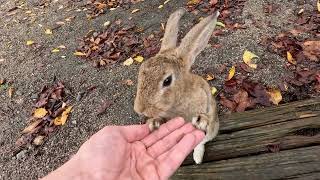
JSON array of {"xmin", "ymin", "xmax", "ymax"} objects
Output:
[{"xmin": 44, "ymin": 118, "xmax": 204, "ymax": 179}]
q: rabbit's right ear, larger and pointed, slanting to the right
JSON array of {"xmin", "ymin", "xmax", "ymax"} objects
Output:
[{"xmin": 177, "ymin": 11, "xmax": 220, "ymax": 68}]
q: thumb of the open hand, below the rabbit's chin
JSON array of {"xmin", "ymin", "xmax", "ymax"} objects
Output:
[{"xmin": 101, "ymin": 124, "xmax": 150, "ymax": 142}]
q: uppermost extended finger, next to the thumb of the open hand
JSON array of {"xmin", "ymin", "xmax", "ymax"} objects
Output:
[{"xmin": 142, "ymin": 118, "xmax": 185, "ymax": 147}]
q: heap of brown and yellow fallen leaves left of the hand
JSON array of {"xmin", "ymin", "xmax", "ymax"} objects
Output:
[{"xmin": 16, "ymin": 82, "xmax": 72, "ymax": 149}]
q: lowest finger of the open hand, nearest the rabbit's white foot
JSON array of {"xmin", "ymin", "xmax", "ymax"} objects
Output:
[{"xmin": 158, "ymin": 130, "xmax": 205, "ymax": 179}]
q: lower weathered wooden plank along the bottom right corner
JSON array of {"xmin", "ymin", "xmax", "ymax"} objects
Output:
[{"xmin": 172, "ymin": 146, "xmax": 320, "ymax": 180}]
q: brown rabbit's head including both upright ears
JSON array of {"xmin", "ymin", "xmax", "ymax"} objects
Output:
[{"xmin": 134, "ymin": 9, "xmax": 219, "ymax": 118}]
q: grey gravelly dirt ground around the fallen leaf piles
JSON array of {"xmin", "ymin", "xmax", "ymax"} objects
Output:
[{"xmin": 0, "ymin": 0, "xmax": 315, "ymax": 179}]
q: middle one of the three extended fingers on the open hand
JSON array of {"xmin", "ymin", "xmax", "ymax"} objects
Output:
[{"xmin": 147, "ymin": 123, "xmax": 195, "ymax": 158}]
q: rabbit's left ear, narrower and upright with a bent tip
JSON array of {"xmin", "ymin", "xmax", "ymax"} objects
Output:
[{"xmin": 160, "ymin": 8, "xmax": 185, "ymax": 53}]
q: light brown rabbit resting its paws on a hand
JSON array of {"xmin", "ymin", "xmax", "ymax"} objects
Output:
[{"xmin": 134, "ymin": 8, "xmax": 219, "ymax": 164}]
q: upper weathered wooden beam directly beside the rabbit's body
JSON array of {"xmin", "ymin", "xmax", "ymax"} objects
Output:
[{"xmin": 183, "ymin": 98, "xmax": 320, "ymax": 165}]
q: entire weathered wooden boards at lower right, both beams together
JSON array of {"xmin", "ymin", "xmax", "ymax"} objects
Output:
[{"xmin": 175, "ymin": 98, "xmax": 320, "ymax": 179}]
